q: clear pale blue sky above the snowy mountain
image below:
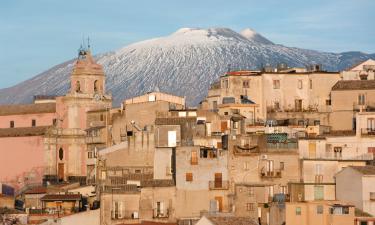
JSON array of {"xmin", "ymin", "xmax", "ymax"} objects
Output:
[{"xmin": 0, "ymin": 0, "xmax": 375, "ymax": 88}]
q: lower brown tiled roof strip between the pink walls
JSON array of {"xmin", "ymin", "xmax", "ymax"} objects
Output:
[{"xmin": 0, "ymin": 126, "xmax": 50, "ymax": 137}]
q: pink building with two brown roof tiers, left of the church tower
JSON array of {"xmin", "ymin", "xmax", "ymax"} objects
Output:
[{"xmin": 0, "ymin": 103, "xmax": 56, "ymax": 188}]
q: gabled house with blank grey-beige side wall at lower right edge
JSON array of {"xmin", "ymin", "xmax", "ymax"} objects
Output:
[{"xmin": 335, "ymin": 166, "xmax": 375, "ymax": 215}]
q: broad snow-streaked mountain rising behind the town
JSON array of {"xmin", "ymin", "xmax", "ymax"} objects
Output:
[{"xmin": 0, "ymin": 28, "xmax": 375, "ymax": 105}]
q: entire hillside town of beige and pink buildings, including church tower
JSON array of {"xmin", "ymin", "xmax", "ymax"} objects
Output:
[{"xmin": 0, "ymin": 45, "xmax": 375, "ymax": 225}]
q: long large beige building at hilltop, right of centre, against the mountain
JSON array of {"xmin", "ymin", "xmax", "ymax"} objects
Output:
[{"xmin": 202, "ymin": 69, "xmax": 341, "ymax": 125}]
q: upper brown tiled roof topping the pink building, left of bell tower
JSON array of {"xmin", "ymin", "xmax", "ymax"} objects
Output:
[{"xmin": 0, "ymin": 103, "xmax": 56, "ymax": 116}]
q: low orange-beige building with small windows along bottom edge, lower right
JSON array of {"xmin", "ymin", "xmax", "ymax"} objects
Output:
[{"xmin": 285, "ymin": 201, "xmax": 355, "ymax": 225}]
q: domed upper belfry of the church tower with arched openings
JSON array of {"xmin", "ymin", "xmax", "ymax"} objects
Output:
[{"xmin": 70, "ymin": 40, "xmax": 105, "ymax": 97}]
